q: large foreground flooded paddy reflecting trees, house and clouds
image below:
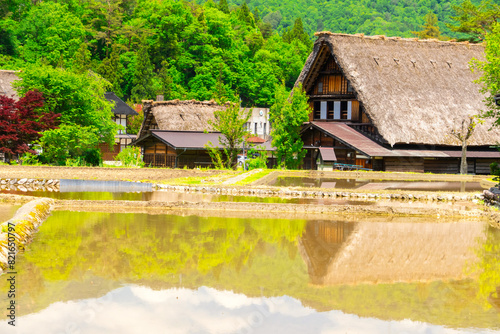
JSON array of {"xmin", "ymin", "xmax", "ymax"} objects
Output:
[{"xmin": 0, "ymin": 211, "xmax": 500, "ymax": 334}]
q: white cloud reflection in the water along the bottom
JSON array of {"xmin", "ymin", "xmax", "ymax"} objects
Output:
[{"xmin": 0, "ymin": 286, "xmax": 491, "ymax": 334}]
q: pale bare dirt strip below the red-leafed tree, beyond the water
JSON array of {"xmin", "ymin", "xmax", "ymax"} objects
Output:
[{"xmin": 0, "ymin": 166, "xmax": 227, "ymax": 182}]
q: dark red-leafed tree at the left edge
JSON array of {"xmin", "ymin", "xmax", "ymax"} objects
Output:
[{"xmin": 0, "ymin": 91, "xmax": 61, "ymax": 160}]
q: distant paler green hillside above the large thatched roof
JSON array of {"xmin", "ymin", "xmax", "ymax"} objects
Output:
[{"xmin": 198, "ymin": 0, "xmax": 500, "ymax": 37}]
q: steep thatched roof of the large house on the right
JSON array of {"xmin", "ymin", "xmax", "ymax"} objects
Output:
[{"xmin": 297, "ymin": 32, "xmax": 500, "ymax": 145}]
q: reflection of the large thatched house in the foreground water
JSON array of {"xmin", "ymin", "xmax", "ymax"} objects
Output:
[{"xmin": 299, "ymin": 221, "xmax": 485, "ymax": 285}]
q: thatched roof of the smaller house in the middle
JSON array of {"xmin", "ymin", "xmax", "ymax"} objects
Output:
[{"xmin": 139, "ymin": 100, "xmax": 225, "ymax": 137}]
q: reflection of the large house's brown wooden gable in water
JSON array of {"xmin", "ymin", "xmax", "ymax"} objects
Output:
[{"xmin": 299, "ymin": 221, "xmax": 356, "ymax": 285}]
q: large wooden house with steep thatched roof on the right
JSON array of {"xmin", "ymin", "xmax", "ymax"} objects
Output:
[{"xmin": 297, "ymin": 32, "xmax": 500, "ymax": 173}]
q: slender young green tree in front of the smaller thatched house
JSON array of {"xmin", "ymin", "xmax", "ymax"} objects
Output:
[{"xmin": 207, "ymin": 103, "xmax": 252, "ymax": 169}]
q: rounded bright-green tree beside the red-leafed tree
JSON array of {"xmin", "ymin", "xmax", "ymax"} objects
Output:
[{"xmin": 14, "ymin": 65, "xmax": 117, "ymax": 164}]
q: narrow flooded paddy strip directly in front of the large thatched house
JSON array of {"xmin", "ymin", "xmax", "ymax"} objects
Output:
[{"xmin": 268, "ymin": 176, "xmax": 483, "ymax": 192}]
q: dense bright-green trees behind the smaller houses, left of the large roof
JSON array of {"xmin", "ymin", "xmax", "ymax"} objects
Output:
[{"xmin": 0, "ymin": 0, "xmax": 312, "ymax": 106}]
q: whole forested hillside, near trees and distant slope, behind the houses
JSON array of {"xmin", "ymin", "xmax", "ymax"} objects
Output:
[{"xmin": 0, "ymin": 0, "xmax": 494, "ymax": 106}]
